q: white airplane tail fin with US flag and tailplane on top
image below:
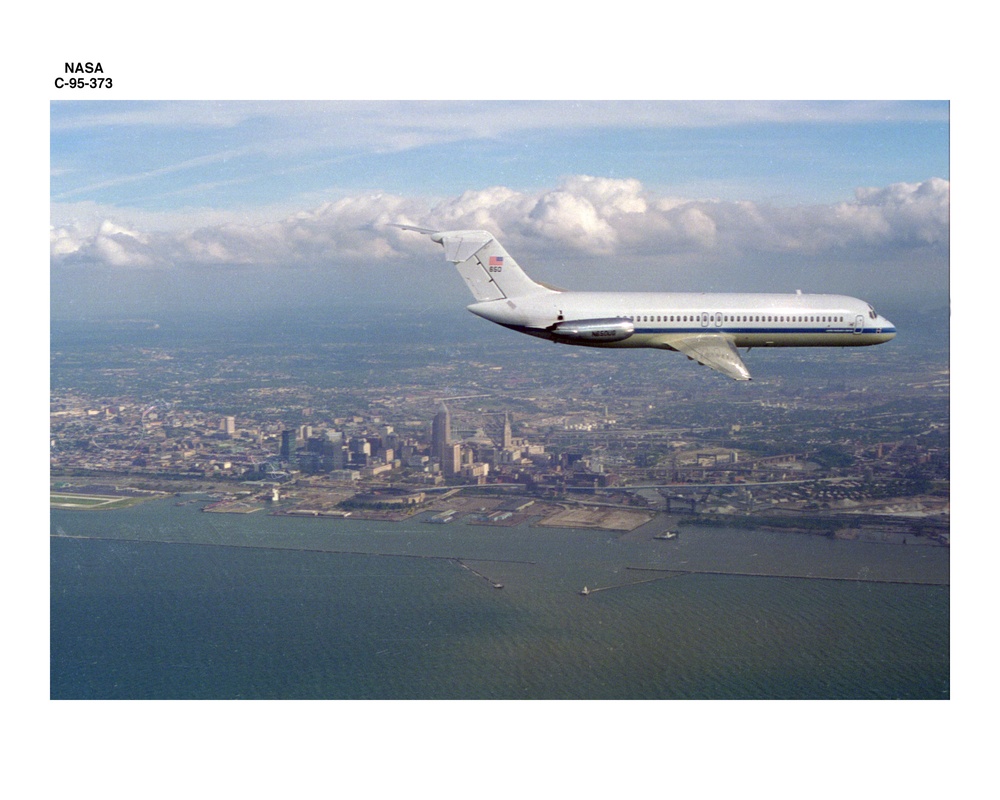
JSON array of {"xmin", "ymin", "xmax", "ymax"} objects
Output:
[{"xmin": 396, "ymin": 224, "xmax": 558, "ymax": 302}]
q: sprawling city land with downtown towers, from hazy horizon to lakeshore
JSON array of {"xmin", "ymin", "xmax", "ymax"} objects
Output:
[{"xmin": 50, "ymin": 324, "xmax": 950, "ymax": 544}]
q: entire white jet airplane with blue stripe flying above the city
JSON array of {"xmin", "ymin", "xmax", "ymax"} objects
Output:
[{"xmin": 396, "ymin": 224, "xmax": 896, "ymax": 381}]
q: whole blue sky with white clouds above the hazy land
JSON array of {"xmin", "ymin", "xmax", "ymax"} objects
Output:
[{"xmin": 50, "ymin": 100, "xmax": 950, "ymax": 316}]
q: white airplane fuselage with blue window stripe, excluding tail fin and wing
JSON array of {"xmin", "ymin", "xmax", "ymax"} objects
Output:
[{"xmin": 468, "ymin": 292, "xmax": 896, "ymax": 347}]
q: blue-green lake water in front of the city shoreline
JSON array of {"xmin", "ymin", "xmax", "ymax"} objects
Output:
[{"xmin": 51, "ymin": 498, "xmax": 950, "ymax": 699}]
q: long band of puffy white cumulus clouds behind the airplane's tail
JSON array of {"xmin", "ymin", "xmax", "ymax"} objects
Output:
[{"xmin": 50, "ymin": 176, "xmax": 950, "ymax": 269}]
